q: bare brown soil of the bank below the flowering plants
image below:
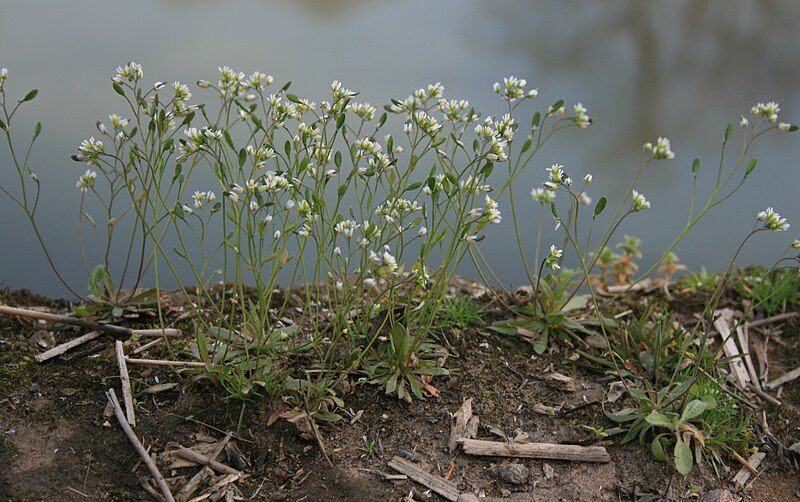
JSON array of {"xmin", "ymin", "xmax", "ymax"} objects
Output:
[{"xmin": 0, "ymin": 284, "xmax": 800, "ymax": 501}]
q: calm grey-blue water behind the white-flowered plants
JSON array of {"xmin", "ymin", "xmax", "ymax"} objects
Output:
[{"xmin": 0, "ymin": 0, "xmax": 800, "ymax": 295}]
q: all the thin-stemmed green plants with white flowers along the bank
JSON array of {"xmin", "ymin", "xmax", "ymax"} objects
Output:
[{"xmin": 0, "ymin": 62, "xmax": 800, "ymax": 474}]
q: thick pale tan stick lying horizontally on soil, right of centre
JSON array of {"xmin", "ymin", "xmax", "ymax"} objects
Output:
[{"xmin": 461, "ymin": 439, "xmax": 611, "ymax": 462}]
